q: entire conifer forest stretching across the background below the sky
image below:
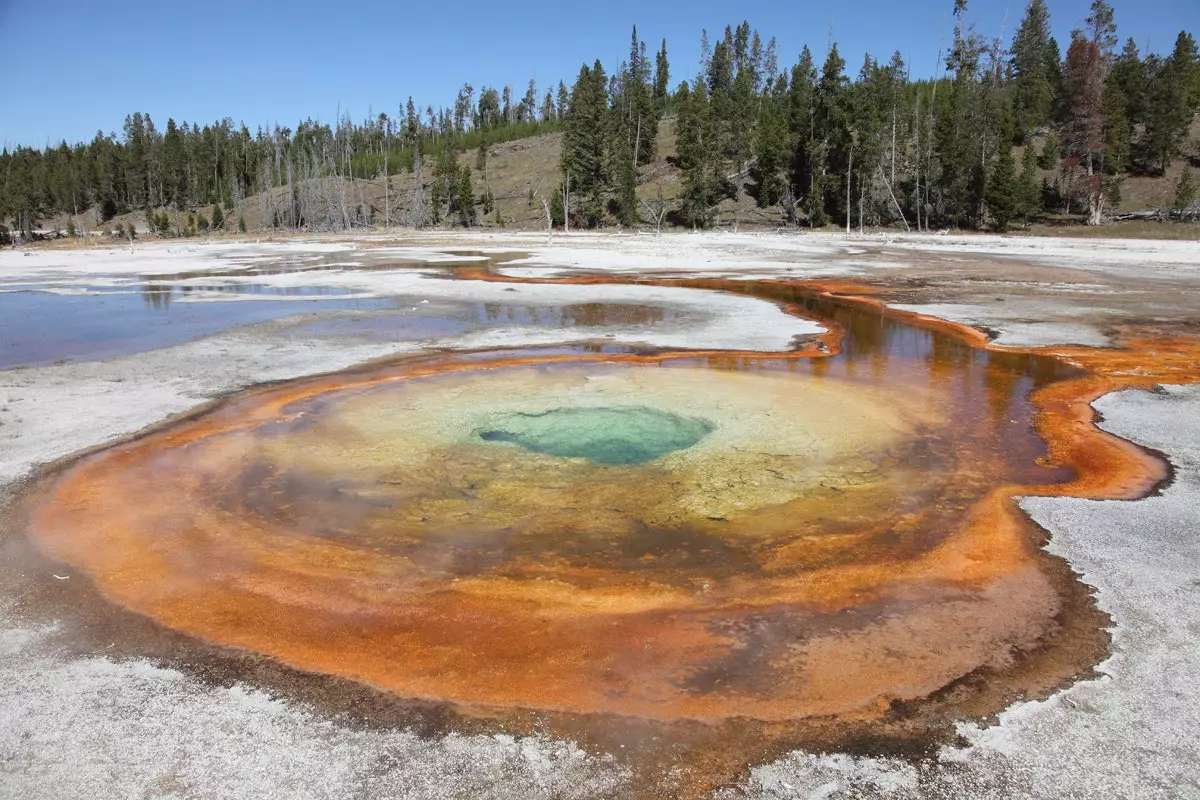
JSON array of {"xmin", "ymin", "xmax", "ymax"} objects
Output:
[{"xmin": 0, "ymin": 0, "xmax": 1200, "ymax": 237}]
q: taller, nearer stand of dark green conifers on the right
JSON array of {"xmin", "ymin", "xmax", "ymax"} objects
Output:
[{"xmin": 562, "ymin": 0, "xmax": 1200, "ymax": 230}]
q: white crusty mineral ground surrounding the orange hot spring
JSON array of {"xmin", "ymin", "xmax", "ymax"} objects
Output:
[{"xmin": 0, "ymin": 234, "xmax": 1200, "ymax": 799}]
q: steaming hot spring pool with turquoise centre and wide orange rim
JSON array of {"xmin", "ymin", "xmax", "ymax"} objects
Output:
[{"xmin": 11, "ymin": 278, "xmax": 1190, "ymax": 794}]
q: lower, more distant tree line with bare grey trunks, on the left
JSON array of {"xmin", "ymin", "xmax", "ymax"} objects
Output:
[{"xmin": 0, "ymin": 79, "xmax": 569, "ymax": 241}]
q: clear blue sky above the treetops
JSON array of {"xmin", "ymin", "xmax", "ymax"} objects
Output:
[{"xmin": 0, "ymin": 0, "xmax": 1200, "ymax": 146}]
